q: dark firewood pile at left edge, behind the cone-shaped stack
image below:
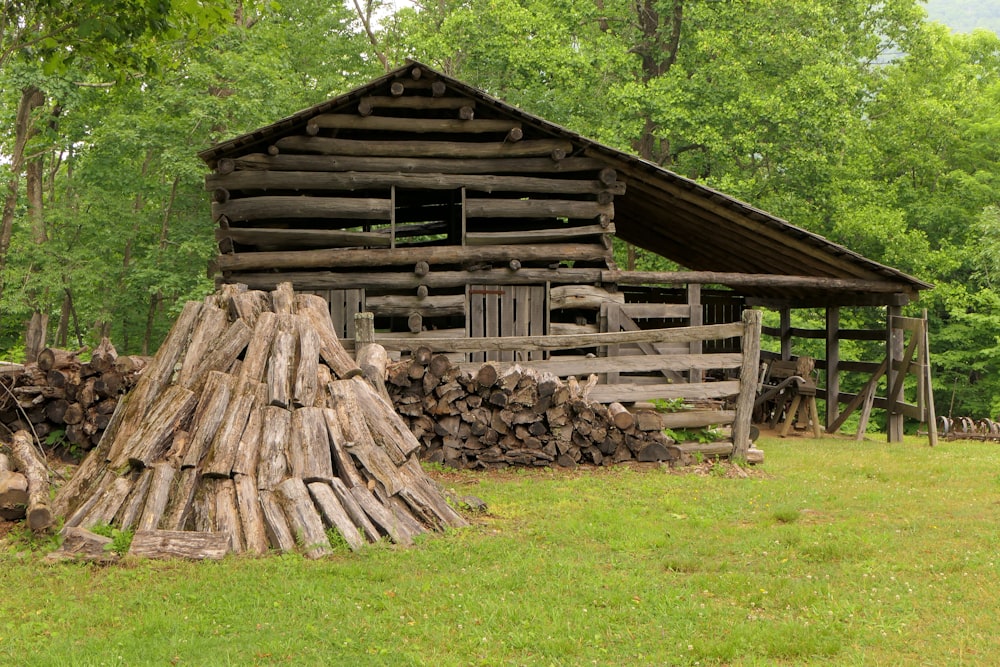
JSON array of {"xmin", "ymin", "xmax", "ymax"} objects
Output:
[{"xmin": 0, "ymin": 338, "xmax": 147, "ymax": 451}]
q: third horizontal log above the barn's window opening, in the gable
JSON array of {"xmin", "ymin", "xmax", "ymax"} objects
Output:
[{"xmin": 277, "ymin": 135, "xmax": 573, "ymax": 163}]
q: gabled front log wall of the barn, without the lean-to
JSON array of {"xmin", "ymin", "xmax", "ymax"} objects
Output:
[{"xmin": 206, "ymin": 67, "xmax": 625, "ymax": 338}]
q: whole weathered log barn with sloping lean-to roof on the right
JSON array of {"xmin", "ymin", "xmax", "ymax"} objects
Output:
[{"xmin": 199, "ymin": 61, "xmax": 930, "ymax": 436}]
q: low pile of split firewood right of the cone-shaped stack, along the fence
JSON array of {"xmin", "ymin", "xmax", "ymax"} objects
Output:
[{"xmin": 386, "ymin": 348, "xmax": 681, "ymax": 468}]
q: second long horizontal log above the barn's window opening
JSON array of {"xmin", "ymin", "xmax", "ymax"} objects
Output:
[{"xmin": 228, "ymin": 153, "xmax": 604, "ymax": 174}]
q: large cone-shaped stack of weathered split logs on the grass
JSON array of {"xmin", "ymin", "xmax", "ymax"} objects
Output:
[{"xmin": 53, "ymin": 284, "xmax": 465, "ymax": 557}]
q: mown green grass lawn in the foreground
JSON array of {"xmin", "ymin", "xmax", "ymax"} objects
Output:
[{"xmin": 0, "ymin": 438, "xmax": 1000, "ymax": 667}]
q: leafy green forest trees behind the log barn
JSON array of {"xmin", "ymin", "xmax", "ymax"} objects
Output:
[{"xmin": 0, "ymin": 0, "xmax": 1000, "ymax": 426}]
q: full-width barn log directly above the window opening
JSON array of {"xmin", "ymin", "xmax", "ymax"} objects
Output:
[{"xmin": 205, "ymin": 170, "xmax": 625, "ymax": 196}]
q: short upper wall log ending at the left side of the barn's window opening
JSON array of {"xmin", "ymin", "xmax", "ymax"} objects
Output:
[{"xmin": 212, "ymin": 195, "xmax": 392, "ymax": 222}]
